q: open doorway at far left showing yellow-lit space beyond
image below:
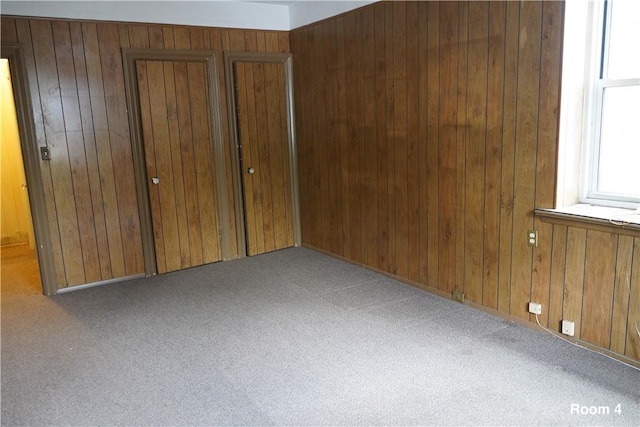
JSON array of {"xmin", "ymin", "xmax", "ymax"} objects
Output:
[{"xmin": 0, "ymin": 58, "xmax": 42, "ymax": 294}]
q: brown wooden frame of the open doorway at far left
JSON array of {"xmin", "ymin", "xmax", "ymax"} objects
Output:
[{"xmin": 0, "ymin": 43, "xmax": 58, "ymax": 296}]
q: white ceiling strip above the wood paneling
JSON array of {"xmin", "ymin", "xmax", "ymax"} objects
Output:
[{"xmin": 0, "ymin": 0, "xmax": 377, "ymax": 31}]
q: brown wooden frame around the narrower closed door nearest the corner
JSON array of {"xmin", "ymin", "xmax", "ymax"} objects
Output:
[{"xmin": 224, "ymin": 52, "xmax": 302, "ymax": 258}]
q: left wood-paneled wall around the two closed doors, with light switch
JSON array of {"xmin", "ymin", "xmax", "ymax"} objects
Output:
[{"xmin": 1, "ymin": 17, "xmax": 289, "ymax": 288}]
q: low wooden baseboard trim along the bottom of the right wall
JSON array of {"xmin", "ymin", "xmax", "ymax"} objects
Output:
[{"xmin": 302, "ymin": 243, "xmax": 640, "ymax": 369}]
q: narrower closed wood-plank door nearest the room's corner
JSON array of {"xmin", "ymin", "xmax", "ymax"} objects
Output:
[{"xmin": 234, "ymin": 61, "xmax": 294, "ymax": 255}]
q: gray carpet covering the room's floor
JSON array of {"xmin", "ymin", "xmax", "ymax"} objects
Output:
[{"xmin": 2, "ymin": 248, "xmax": 640, "ymax": 425}]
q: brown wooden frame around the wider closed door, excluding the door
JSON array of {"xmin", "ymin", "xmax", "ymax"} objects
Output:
[{"xmin": 122, "ymin": 49, "xmax": 233, "ymax": 276}]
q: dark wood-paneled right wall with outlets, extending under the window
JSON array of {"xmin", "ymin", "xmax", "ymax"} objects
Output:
[{"xmin": 291, "ymin": 1, "xmax": 640, "ymax": 359}]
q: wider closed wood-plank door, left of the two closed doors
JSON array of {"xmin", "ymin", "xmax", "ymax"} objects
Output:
[{"xmin": 136, "ymin": 60, "xmax": 221, "ymax": 273}]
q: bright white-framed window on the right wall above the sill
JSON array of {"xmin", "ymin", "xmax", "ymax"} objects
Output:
[{"xmin": 580, "ymin": 0, "xmax": 640, "ymax": 208}]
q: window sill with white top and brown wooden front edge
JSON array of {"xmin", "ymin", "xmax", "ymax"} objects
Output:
[{"xmin": 535, "ymin": 204, "xmax": 640, "ymax": 237}]
